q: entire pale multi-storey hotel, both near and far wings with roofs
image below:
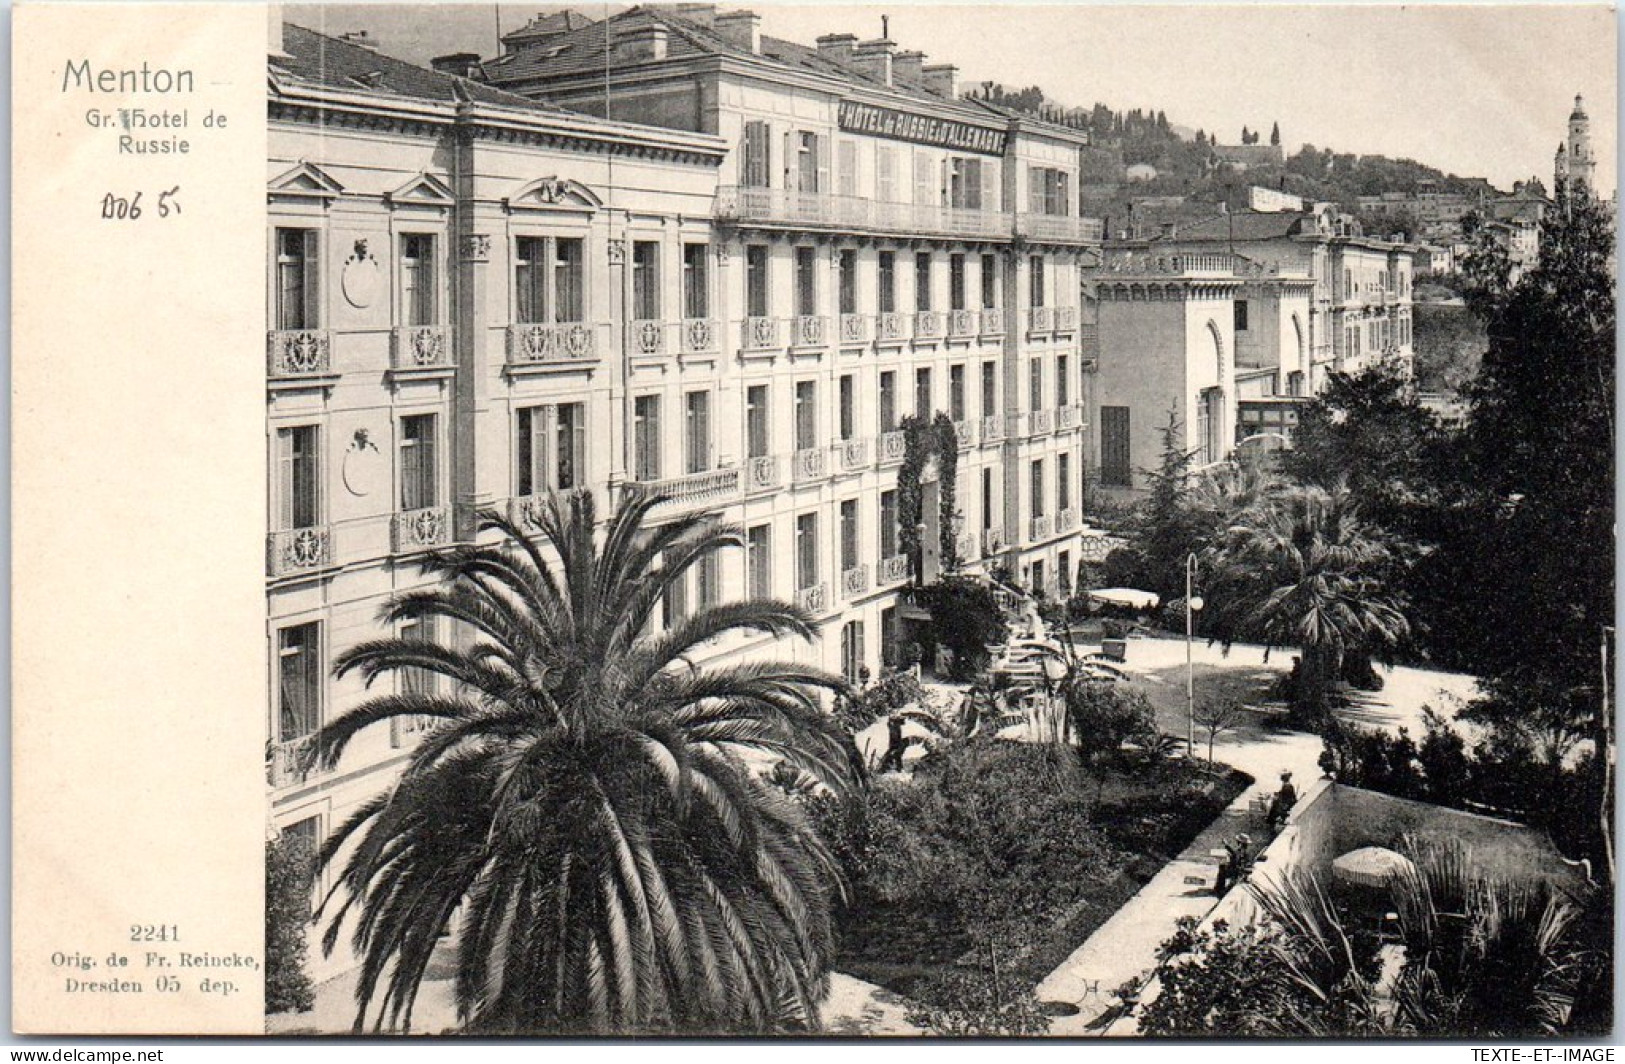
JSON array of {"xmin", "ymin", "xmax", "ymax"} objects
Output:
[{"xmin": 267, "ymin": 10, "xmax": 1100, "ymax": 978}]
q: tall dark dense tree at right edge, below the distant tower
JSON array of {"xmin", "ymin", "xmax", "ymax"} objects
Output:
[{"xmin": 1456, "ymin": 187, "xmax": 1617, "ymax": 799}]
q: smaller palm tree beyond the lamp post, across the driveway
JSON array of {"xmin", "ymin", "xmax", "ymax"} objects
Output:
[{"xmin": 1209, "ymin": 484, "xmax": 1411, "ymax": 723}]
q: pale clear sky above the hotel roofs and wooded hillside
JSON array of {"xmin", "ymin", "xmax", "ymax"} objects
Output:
[{"xmin": 295, "ymin": 0, "xmax": 1619, "ymax": 192}]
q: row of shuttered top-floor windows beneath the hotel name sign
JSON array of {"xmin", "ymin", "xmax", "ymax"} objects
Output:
[{"xmin": 739, "ymin": 120, "xmax": 1073, "ymax": 214}]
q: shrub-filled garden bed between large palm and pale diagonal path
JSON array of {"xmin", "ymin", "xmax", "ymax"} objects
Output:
[{"xmin": 817, "ymin": 739, "xmax": 1250, "ymax": 1002}]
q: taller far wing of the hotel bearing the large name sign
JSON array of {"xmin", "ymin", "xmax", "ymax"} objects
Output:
[{"xmin": 483, "ymin": 5, "xmax": 1100, "ymax": 620}]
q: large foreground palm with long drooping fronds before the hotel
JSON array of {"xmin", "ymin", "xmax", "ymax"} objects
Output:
[{"xmin": 315, "ymin": 489, "xmax": 855, "ymax": 1033}]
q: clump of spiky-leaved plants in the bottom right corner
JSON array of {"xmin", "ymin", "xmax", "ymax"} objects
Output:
[{"xmin": 1141, "ymin": 838, "xmax": 1606, "ymax": 1038}]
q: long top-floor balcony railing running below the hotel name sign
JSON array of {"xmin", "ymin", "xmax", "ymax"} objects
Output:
[{"xmin": 712, "ymin": 185, "xmax": 1011, "ymax": 245}]
